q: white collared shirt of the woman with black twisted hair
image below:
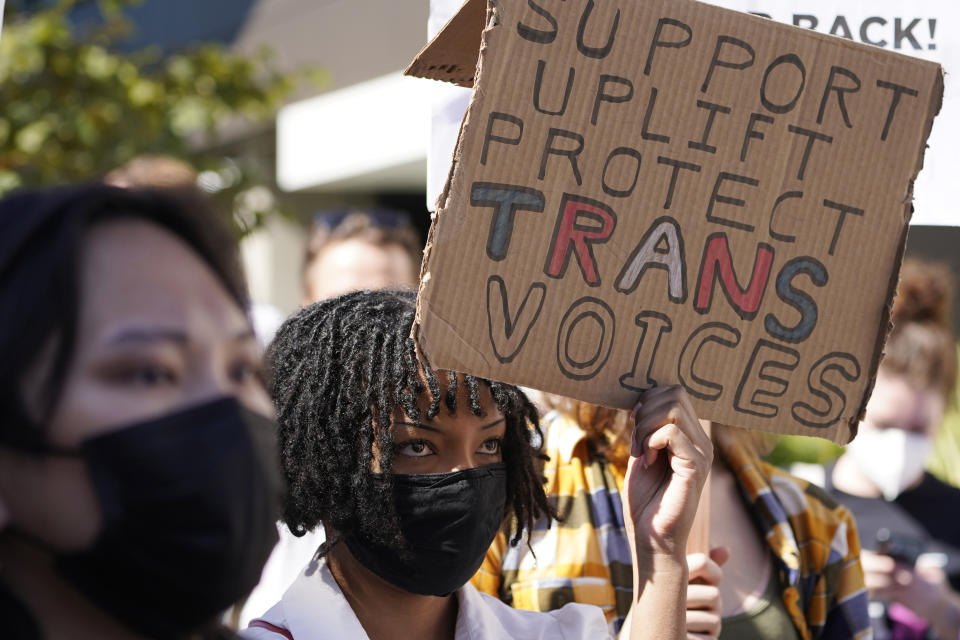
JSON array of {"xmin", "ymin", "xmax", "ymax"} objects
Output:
[{"xmin": 240, "ymin": 559, "xmax": 610, "ymax": 640}]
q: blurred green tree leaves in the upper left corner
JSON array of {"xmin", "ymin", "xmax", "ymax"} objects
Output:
[{"xmin": 0, "ymin": 0, "xmax": 315, "ymax": 232}]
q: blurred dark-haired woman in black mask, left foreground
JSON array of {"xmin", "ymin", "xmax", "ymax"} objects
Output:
[{"xmin": 0, "ymin": 186, "xmax": 280, "ymax": 640}]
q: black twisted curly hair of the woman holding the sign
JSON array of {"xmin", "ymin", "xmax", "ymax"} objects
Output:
[{"xmin": 267, "ymin": 291, "xmax": 556, "ymax": 555}]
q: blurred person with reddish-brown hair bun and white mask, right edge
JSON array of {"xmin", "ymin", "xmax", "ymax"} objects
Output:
[{"xmin": 825, "ymin": 261, "xmax": 960, "ymax": 640}]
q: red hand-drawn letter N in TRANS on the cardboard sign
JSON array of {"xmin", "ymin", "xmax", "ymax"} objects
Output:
[{"xmin": 693, "ymin": 232, "xmax": 773, "ymax": 320}]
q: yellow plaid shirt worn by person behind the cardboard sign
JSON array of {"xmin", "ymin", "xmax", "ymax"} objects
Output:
[{"xmin": 472, "ymin": 412, "xmax": 871, "ymax": 640}]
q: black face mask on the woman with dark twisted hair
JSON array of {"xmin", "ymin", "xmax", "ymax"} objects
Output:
[{"xmin": 344, "ymin": 463, "xmax": 507, "ymax": 596}]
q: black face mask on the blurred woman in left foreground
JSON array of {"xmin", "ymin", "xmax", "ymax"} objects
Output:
[{"xmin": 36, "ymin": 398, "xmax": 281, "ymax": 638}]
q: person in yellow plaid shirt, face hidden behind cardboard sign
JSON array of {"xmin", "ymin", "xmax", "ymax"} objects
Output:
[{"xmin": 473, "ymin": 400, "xmax": 869, "ymax": 640}]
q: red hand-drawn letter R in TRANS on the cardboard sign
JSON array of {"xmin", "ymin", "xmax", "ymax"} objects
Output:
[{"xmin": 543, "ymin": 193, "xmax": 617, "ymax": 287}]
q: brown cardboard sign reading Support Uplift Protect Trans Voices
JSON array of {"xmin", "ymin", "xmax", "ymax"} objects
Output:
[{"xmin": 408, "ymin": 0, "xmax": 943, "ymax": 442}]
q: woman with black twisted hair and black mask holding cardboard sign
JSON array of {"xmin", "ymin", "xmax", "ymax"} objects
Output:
[{"xmin": 245, "ymin": 291, "xmax": 712, "ymax": 640}]
